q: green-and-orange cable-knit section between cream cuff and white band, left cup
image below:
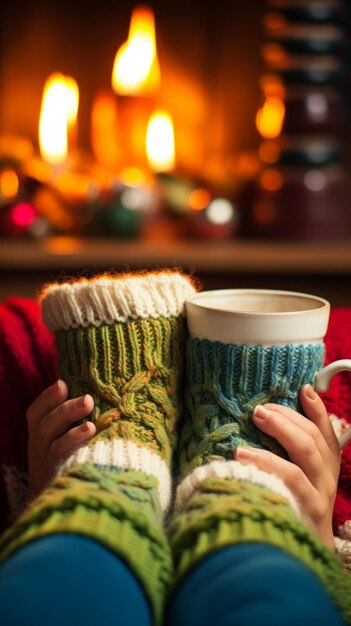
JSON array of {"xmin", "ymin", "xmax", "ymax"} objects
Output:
[{"xmin": 56, "ymin": 317, "xmax": 185, "ymax": 464}]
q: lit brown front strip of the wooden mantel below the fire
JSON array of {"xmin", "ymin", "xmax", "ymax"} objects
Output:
[{"xmin": 0, "ymin": 237, "xmax": 351, "ymax": 274}]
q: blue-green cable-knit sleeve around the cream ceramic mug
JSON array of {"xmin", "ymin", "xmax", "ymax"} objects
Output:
[{"xmin": 179, "ymin": 339, "xmax": 324, "ymax": 476}]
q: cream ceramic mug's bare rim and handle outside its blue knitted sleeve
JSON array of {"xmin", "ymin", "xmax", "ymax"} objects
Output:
[{"xmin": 186, "ymin": 289, "xmax": 351, "ymax": 392}]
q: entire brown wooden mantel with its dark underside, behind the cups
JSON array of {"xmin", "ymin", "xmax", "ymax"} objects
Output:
[{"xmin": 0, "ymin": 237, "xmax": 351, "ymax": 306}]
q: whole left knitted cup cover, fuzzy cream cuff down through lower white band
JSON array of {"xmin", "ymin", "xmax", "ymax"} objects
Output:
[{"xmin": 41, "ymin": 271, "xmax": 194, "ymax": 508}]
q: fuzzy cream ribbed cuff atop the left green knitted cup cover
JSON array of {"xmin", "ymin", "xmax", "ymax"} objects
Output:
[{"xmin": 40, "ymin": 272, "xmax": 194, "ymax": 332}]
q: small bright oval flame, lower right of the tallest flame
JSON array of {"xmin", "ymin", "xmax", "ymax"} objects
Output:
[{"xmin": 146, "ymin": 110, "xmax": 175, "ymax": 172}]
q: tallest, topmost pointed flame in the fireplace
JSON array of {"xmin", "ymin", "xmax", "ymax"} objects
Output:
[{"xmin": 112, "ymin": 7, "xmax": 160, "ymax": 96}]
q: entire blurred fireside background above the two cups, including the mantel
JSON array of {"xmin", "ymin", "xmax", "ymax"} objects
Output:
[{"xmin": 0, "ymin": 0, "xmax": 351, "ymax": 306}]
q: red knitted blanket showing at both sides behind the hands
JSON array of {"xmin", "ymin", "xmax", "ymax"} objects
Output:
[{"xmin": 0, "ymin": 298, "xmax": 351, "ymax": 530}]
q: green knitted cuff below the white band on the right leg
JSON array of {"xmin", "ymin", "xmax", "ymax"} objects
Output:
[{"xmin": 169, "ymin": 472, "xmax": 351, "ymax": 623}]
